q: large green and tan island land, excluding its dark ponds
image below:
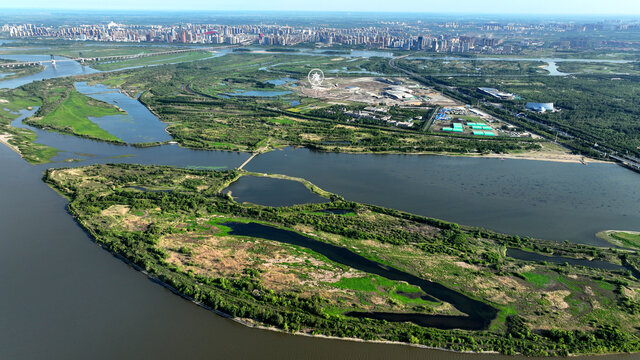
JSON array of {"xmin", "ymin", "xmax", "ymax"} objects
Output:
[{"xmin": 45, "ymin": 165, "xmax": 640, "ymax": 355}]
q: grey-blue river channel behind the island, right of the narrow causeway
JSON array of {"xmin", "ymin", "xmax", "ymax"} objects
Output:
[{"xmin": 245, "ymin": 149, "xmax": 640, "ymax": 246}]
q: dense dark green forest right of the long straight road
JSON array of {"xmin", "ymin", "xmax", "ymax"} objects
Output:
[{"xmin": 398, "ymin": 60, "xmax": 640, "ymax": 158}]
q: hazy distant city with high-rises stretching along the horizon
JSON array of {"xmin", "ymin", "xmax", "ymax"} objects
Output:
[{"xmin": 5, "ymin": 20, "xmax": 640, "ymax": 54}]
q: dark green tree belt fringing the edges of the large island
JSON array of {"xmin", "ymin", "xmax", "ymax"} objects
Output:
[{"xmin": 45, "ymin": 164, "xmax": 640, "ymax": 355}]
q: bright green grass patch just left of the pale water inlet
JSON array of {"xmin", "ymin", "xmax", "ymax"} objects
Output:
[{"xmin": 29, "ymin": 89, "xmax": 124, "ymax": 142}]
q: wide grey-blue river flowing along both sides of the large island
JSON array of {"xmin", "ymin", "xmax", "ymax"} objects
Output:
[{"xmin": 0, "ymin": 50, "xmax": 640, "ymax": 360}]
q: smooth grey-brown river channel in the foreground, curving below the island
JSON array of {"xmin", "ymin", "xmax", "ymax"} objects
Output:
[{"xmin": 0, "ymin": 147, "xmax": 635, "ymax": 360}]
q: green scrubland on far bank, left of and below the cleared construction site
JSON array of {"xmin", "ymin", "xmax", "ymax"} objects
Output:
[{"xmin": 72, "ymin": 53, "xmax": 540, "ymax": 153}]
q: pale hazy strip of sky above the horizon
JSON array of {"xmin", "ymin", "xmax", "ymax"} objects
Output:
[{"xmin": 0, "ymin": 0, "xmax": 640, "ymax": 15}]
